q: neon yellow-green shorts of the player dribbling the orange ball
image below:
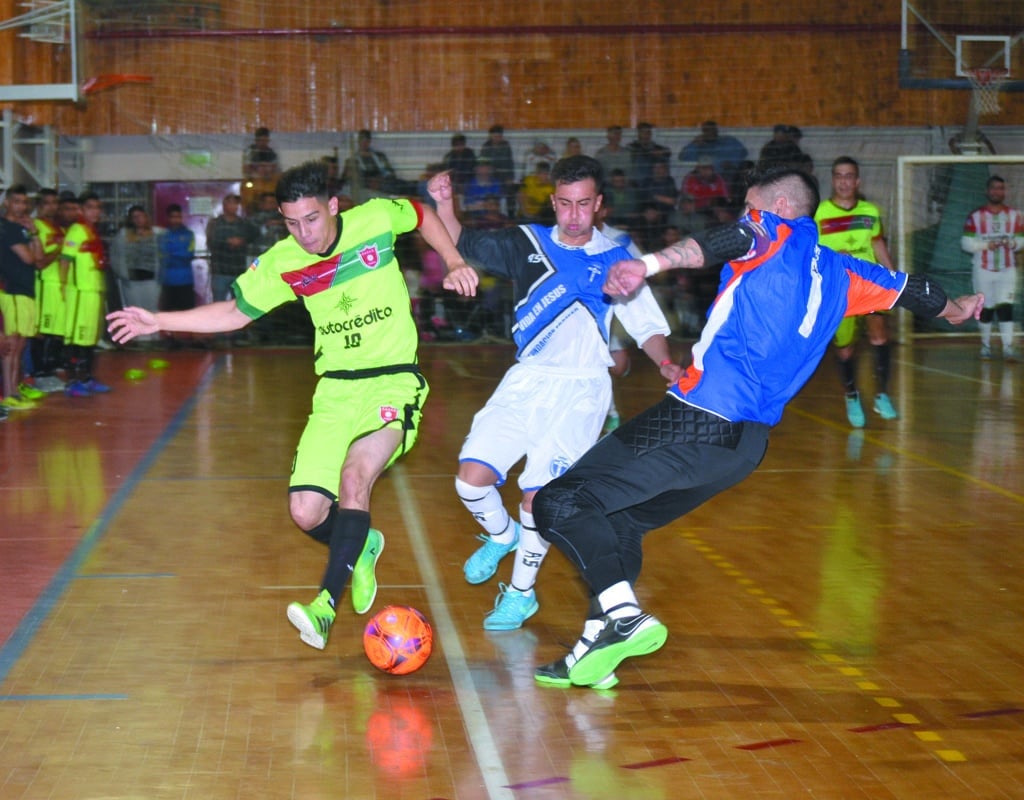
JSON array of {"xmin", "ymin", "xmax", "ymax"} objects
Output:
[{"xmin": 288, "ymin": 372, "xmax": 430, "ymax": 500}]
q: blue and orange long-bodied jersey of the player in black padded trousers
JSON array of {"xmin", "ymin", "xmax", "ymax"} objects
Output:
[{"xmin": 669, "ymin": 211, "xmax": 907, "ymax": 425}]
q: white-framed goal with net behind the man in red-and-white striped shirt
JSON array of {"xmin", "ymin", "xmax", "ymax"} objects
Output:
[{"xmin": 895, "ymin": 155, "xmax": 1024, "ymax": 341}]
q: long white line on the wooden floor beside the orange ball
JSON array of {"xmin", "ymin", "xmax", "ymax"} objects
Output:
[{"xmin": 390, "ymin": 464, "xmax": 515, "ymax": 800}]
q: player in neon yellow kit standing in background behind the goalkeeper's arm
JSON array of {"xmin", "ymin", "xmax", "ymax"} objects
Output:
[{"xmin": 814, "ymin": 156, "xmax": 899, "ymax": 428}]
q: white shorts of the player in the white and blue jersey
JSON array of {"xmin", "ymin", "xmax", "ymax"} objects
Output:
[{"xmin": 459, "ymin": 364, "xmax": 611, "ymax": 492}]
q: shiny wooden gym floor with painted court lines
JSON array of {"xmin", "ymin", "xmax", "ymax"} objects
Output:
[{"xmin": 0, "ymin": 339, "xmax": 1024, "ymax": 800}]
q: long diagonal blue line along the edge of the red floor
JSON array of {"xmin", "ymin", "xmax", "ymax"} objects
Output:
[{"xmin": 0, "ymin": 355, "xmax": 224, "ymax": 683}]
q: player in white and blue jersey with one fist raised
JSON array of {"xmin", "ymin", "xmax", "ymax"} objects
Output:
[{"xmin": 429, "ymin": 156, "xmax": 680, "ymax": 667}]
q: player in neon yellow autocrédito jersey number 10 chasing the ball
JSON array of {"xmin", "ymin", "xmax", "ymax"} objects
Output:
[{"xmin": 108, "ymin": 162, "xmax": 477, "ymax": 649}]
